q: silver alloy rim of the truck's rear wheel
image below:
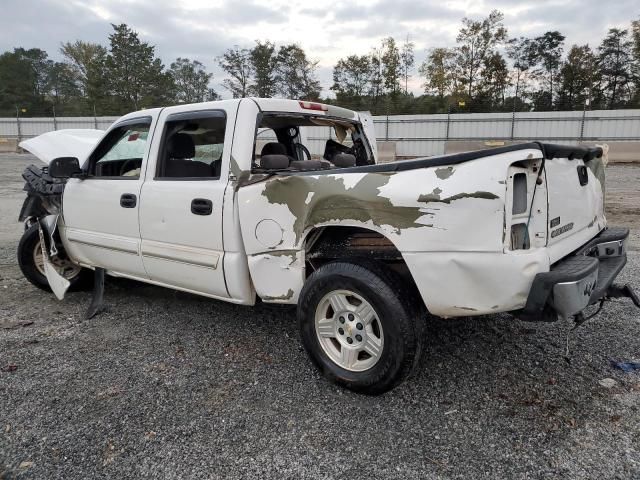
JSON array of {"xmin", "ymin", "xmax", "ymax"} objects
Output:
[{"xmin": 315, "ymin": 290, "xmax": 384, "ymax": 372}]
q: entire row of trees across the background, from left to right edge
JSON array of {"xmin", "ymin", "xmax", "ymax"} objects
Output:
[{"xmin": 0, "ymin": 10, "xmax": 640, "ymax": 116}]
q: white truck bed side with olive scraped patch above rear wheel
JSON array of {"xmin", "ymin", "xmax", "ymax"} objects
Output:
[{"xmin": 238, "ymin": 150, "xmax": 548, "ymax": 316}]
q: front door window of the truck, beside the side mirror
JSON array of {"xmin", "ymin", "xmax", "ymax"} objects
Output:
[{"xmin": 89, "ymin": 118, "xmax": 151, "ymax": 179}]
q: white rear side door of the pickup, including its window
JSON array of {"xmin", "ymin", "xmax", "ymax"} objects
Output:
[{"xmin": 140, "ymin": 107, "xmax": 233, "ymax": 298}]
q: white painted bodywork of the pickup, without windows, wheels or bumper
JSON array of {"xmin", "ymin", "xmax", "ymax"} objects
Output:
[{"xmin": 23, "ymin": 99, "xmax": 606, "ymax": 317}]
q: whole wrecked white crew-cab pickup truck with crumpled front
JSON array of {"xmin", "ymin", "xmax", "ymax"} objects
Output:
[{"xmin": 18, "ymin": 98, "xmax": 640, "ymax": 394}]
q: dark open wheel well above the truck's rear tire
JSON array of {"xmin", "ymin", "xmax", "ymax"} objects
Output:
[{"xmin": 304, "ymin": 226, "xmax": 421, "ymax": 310}]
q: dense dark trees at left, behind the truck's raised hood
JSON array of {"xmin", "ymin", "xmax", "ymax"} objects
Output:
[{"xmin": 0, "ymin": 24, "xmax": 217, "ymax": 116}]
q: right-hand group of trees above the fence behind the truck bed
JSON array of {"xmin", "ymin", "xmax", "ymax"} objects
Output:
[{"xmin": 331, "ymin": 10, "xmax": 640, "ymax": 113}]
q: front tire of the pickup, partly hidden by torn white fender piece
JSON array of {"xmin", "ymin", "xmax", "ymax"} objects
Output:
[{"xmin": 18, "ymin": 223, "xmax": 93, "ymax": 292}]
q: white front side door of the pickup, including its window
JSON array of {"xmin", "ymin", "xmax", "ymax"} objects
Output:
[{"xmin": 61, "ymin": 111, "xmax": 157, "ymax": 279}]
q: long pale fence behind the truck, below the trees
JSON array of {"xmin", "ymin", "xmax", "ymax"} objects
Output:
[{"xmin": 0, "ymin": 110, "xmax": 640, "ymax": 160}]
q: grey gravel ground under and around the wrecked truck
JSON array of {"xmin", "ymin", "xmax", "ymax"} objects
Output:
[{"xmin": 0, "ymin": 156, "xmax": 640, "ymax": 479}]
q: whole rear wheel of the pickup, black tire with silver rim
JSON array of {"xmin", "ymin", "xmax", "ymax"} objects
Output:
[{"xmin": 297, "ymin": 262, "xmax": 424, "ymax": 395}]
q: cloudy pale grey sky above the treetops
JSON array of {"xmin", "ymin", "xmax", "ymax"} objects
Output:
[{"xmin": 0, "ymin": 0, "xmax": 640, "ymax": 97}]
